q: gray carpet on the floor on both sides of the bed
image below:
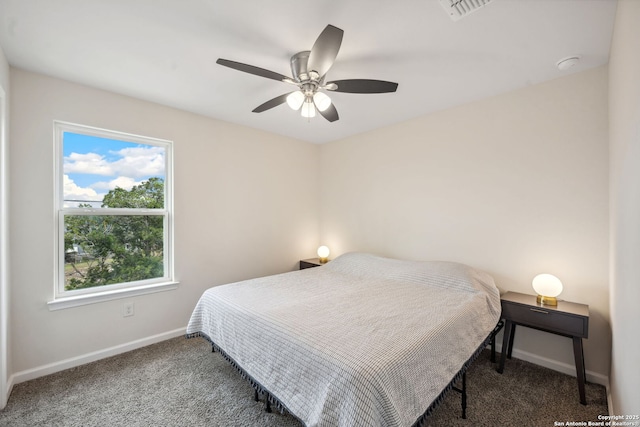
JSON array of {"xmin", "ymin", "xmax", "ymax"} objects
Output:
[{"xmin": 0, "ymin": 338, "xmax": 608, "ymax": 427}]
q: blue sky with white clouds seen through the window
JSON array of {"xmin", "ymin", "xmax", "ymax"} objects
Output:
[{"xmin": 62, "ymin": 132, "xmax": 165, "ymax": 207}]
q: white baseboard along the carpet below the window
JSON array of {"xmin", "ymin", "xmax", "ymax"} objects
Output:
[{"xmin": 7, "ymin": 327, "xmax": 187, "ymax": 388}]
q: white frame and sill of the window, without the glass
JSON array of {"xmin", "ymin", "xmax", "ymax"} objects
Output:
[{"xmin": 48, "ymin": 120, "xmax": 178, "ymax": 310}]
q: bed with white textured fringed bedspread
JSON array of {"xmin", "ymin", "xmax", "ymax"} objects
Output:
[{"xmin": 187, "ymin": 253, "xmax": 500, "ymax": 427}]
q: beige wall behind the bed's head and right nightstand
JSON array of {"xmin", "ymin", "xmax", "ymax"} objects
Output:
[{"xmin": 320, "ymin": 67, "xmax": 610, "ymax": 382}]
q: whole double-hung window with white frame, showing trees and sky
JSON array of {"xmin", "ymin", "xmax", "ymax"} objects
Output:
[{"xmin": 50, "ymin": 122, "xmax": 176, "ymax": 309}]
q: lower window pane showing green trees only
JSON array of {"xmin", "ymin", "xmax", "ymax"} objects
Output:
[{"xmin": 64, "ymin": 215, "xmax": 164, "ymax": 291}]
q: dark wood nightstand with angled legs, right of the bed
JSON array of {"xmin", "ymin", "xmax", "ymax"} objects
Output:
[{"xmin": 498, "ymin": 292, "xmax": 589, "ymax": 405}]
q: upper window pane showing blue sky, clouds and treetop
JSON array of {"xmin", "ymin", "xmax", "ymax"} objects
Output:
[{"xmin": 62, "ymin": 131, "xmax": 166, "ymax": 209}]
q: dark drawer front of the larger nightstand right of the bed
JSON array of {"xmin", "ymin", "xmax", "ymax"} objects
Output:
[{"xmin": 502, "ymin": 301, "xmax": 589, "ymax": 338}]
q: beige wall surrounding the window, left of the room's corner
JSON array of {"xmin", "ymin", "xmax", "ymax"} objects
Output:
[{"xmin": 10, "ymin": 69, "xmax": 319, "ymax": 380}]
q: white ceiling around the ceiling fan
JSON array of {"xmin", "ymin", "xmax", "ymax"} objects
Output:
[{"xmin": 0, "ymin": 0, "xmax": 616, "ymax": 143}]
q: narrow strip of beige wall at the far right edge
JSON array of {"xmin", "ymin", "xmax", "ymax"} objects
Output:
[{"xmin": 609, "ymin": 0, "xmax": 640, "ymax": 414}]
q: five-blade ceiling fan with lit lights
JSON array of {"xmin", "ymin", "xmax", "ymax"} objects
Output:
[{"xmin": 216, "ymin": 25, "xmax": 398, "ymax": 122}]
